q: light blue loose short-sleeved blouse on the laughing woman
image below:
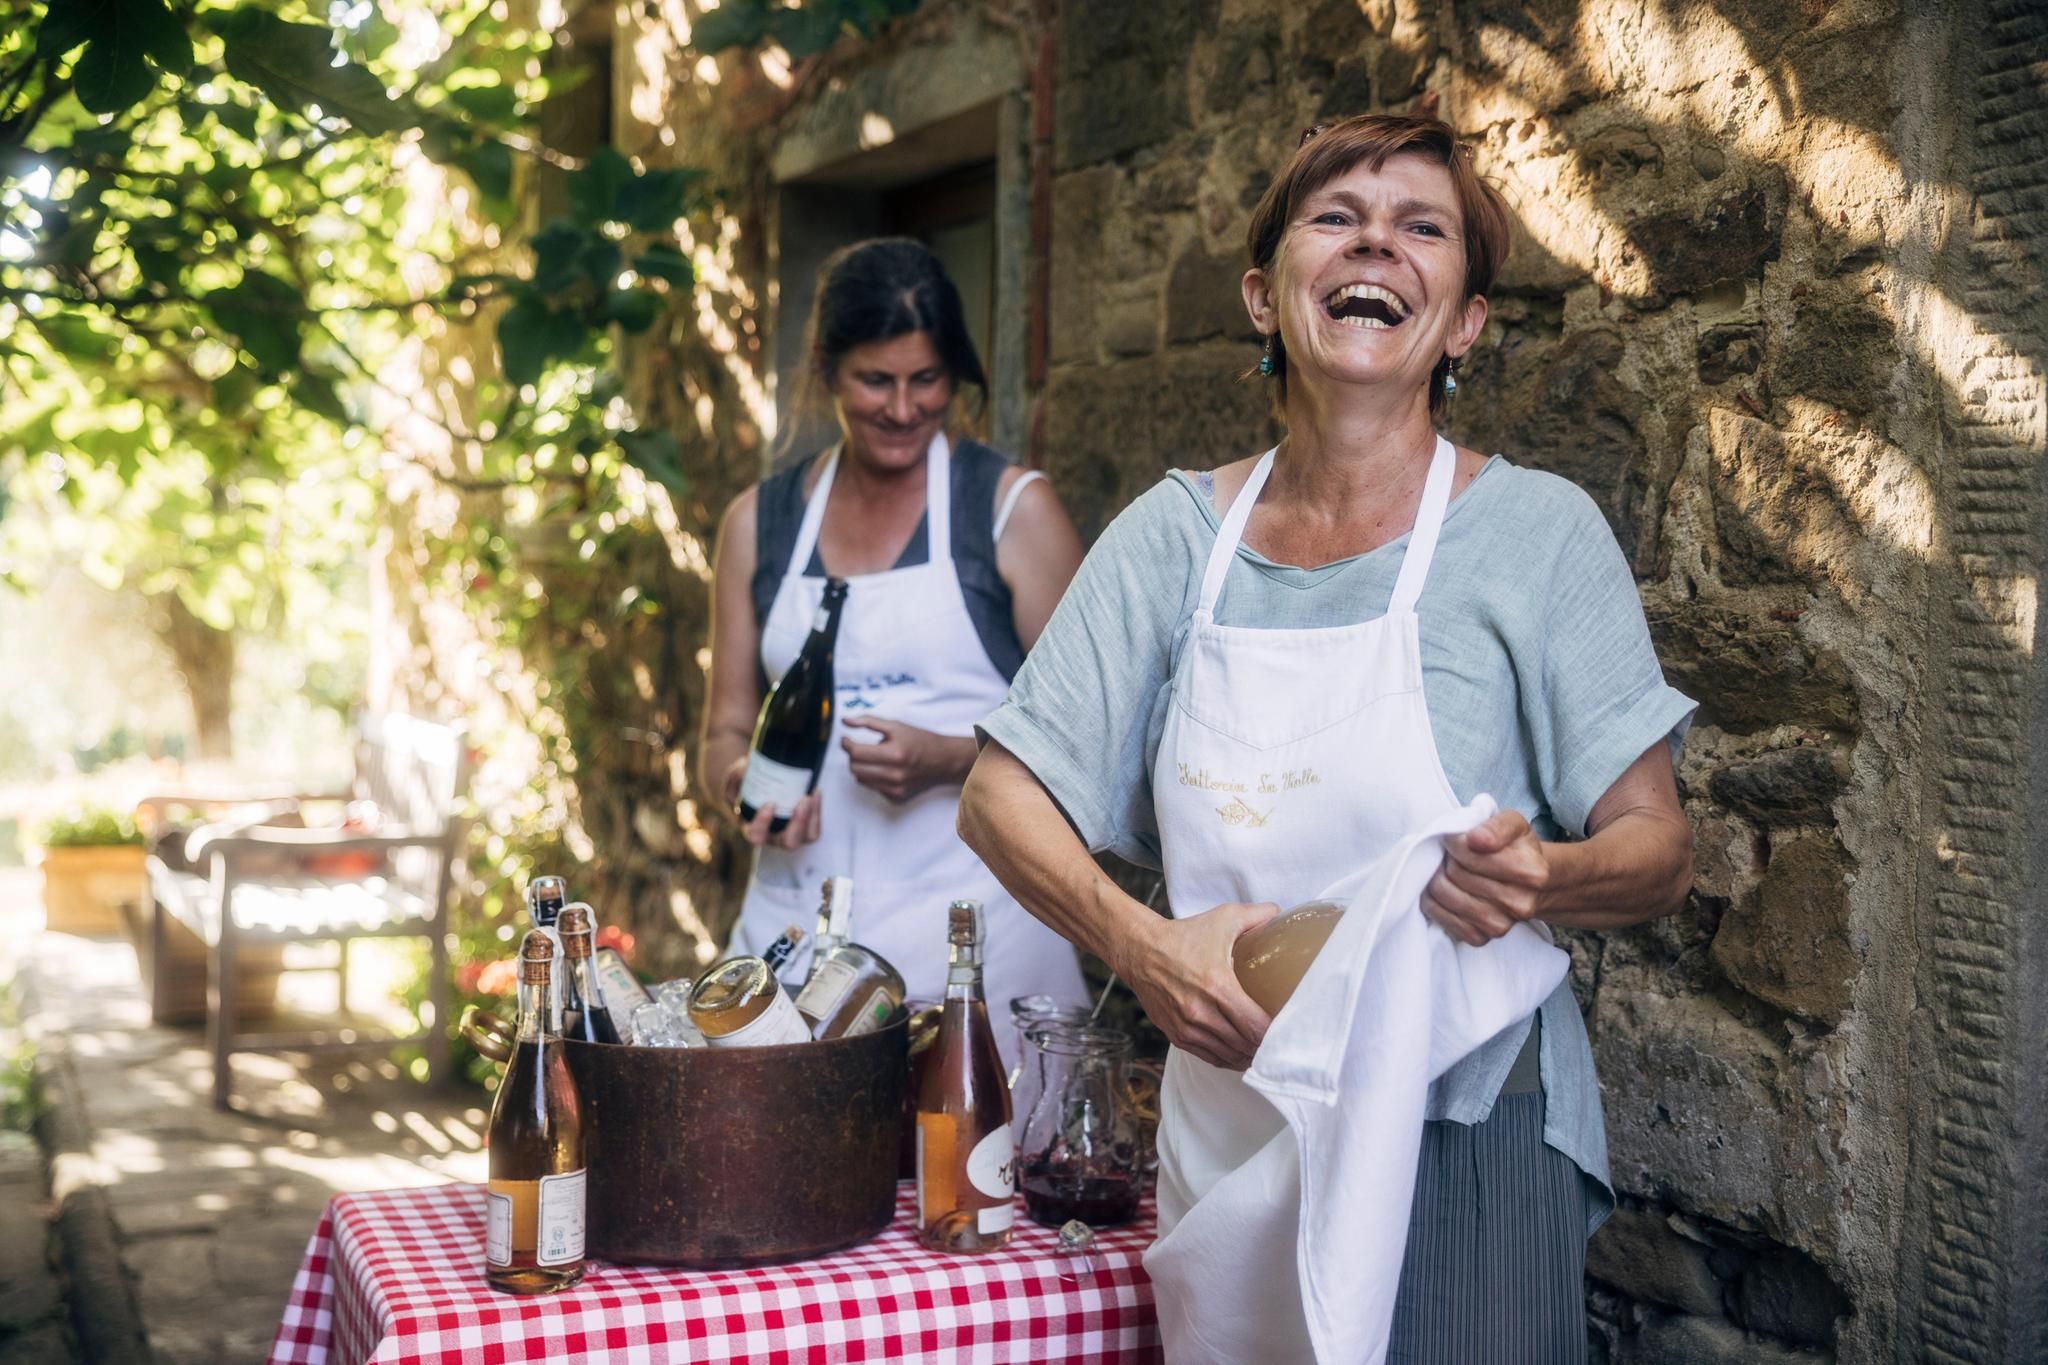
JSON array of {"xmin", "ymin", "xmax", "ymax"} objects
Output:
[{"xmin": 981, "ymin": 456, "xmax": 1694, "ymax": 1232}]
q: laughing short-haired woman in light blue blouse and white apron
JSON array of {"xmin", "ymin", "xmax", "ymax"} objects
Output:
[{"xmin": 961, "ymin": 117, "xmax": 1694, "ymax": 1365}]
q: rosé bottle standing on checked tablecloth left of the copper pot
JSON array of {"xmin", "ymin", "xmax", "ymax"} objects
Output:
[{"xmin": 483, "ymin": 929, "xmax": 584, "ymax": 1293}]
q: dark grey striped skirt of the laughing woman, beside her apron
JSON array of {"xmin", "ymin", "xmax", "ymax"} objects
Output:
[{"xmin": 1386, "ymin": 1089, "xmax": 1587, "ymax": 1365}]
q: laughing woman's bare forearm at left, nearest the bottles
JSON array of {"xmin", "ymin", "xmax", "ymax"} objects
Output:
[{"xmin": 958, "ymin": 743, "xmax": 1159, "ymax": 972}]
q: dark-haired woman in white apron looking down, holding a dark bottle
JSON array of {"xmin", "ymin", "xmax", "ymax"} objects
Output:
[{"xmin": 698, "ymin": 237, "xmax": 1081, "ymax": 1046}]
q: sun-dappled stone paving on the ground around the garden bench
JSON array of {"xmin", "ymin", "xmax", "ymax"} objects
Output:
[{"xmin": 0, "ymin": 872, "xmax": 487, "ymax": 1365}]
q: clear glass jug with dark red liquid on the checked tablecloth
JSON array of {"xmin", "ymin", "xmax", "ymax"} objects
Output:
[{"xmin": 1018, "ymin": 1021, "xmax": 1145, "ymax": 1228}]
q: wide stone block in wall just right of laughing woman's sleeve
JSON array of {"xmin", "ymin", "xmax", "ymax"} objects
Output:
[{"xmin": 1645, "ymin": 598, "xmax": 1860, "ymax": 735}]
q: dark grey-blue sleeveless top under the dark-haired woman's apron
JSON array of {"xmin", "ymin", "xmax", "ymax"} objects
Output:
[{"xmin": 752, "ymin": 440, "xmax": 1024, "ymax": 681}]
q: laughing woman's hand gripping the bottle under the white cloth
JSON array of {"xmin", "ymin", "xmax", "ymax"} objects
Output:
[{"xmin": 1120, "ymin": 902, "xmax": 1280, "ymax": 1070}]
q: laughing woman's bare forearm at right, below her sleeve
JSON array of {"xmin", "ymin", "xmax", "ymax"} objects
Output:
[{"xmin": 1536, "ymin": 808, "xmax": 1692, "ymax": 929}]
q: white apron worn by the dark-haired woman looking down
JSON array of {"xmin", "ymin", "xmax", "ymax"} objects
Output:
[{"xmin": 727, "ymin": 434, "xmax": 1085, "ymax": 1064}]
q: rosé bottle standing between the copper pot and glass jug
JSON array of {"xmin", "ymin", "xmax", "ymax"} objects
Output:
[{"xmin": 918, "ymin": 900, "xmax": 1016, "ymax": 1252}]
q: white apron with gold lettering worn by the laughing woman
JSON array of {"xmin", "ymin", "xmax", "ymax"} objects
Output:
[{"xmin": 1145, "ymin": 438, "xmax": 1567, "ymax": 1365}]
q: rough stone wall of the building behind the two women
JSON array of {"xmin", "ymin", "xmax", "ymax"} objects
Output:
[{"xmin": 407, "ymin": 0, "xmax": 2048, "ymax": 1363}]
